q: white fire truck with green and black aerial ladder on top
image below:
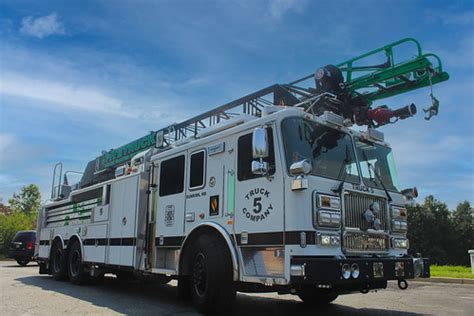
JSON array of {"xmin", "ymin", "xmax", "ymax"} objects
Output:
[{"xmin": 36, "ymin": 38, "xmax": 449, "ymax": 312}]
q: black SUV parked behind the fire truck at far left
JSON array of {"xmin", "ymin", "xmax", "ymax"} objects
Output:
[{"xmin": 8, "ymin": 230, "xmax": 36, "ymax": 266}]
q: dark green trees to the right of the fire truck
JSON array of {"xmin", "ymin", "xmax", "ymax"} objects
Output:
[{"xmin": 407, "ymin": 196, "xmax": 474, "ymax": 266}]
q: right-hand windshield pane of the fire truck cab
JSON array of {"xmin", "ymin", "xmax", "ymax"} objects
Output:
[{"xmin": 355, "ymin": 138, "xmax": 400, "ymax": 192}]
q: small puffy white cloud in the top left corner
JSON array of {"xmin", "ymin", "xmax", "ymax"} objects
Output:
[{"xmin": 20, "ymin": 13, "xmax": 65, "ymax": 38}]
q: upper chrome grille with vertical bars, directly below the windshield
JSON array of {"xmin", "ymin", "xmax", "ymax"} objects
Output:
[{"xmin": 344, "ymin": 191, "xmax": 388, "ymax": 231}]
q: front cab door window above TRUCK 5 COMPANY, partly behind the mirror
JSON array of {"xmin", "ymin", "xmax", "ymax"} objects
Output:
[{"xmin": 237, "ymin": 127, "xmax": 275, "ymax": 181}]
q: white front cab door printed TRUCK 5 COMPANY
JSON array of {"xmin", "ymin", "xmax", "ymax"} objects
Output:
[{"xmin": 235, "ymin": 127, "xmax": 285, "ymax": 247}]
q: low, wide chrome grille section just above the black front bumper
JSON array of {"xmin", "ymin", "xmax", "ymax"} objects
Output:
[{"xmin": 343, "ymin": 233, "xmax": 389, "ymax": 252}]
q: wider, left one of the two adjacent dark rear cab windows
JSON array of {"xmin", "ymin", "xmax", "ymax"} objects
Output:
[{"xmin": 159, "ymin": 155, "xmax": 184, "ymax": 196}]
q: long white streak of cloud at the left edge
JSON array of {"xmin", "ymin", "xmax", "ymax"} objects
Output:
[{"xmin": 0, "ymin": 73, "xmax": 136, "ymax": 116}]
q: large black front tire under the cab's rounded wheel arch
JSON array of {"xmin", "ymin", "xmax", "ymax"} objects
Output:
[{"xmin": 190, "ymin": 235, "xmax": 236, "ymax": 313}]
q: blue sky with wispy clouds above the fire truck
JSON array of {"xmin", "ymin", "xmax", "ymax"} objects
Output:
[{"xmin": 0, "ymin": 0, "xmax": 474, "ymax": 208}]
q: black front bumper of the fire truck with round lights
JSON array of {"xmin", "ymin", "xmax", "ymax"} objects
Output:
[{"xmin": 291, "ymin": 256, "xmax": 430, "ymax": 289}]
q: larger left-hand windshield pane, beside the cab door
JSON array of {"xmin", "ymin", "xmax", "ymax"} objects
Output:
[{"xmin": 282, "ymin": 117, "xmax": 359, "ymax": 183}]
